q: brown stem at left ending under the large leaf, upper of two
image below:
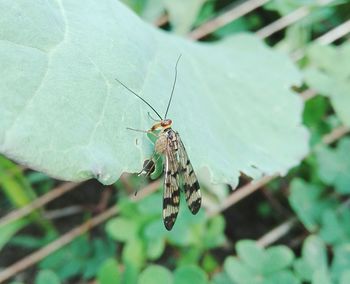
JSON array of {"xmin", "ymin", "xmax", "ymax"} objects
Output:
[{"xmin": 0, "ymin": 182, "xmax": 81, "ymax": 228}]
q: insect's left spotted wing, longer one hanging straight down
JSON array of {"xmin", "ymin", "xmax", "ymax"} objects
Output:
[{"xmin": 163, "ymin": 140, "xmax": 180, "ymax": 231}]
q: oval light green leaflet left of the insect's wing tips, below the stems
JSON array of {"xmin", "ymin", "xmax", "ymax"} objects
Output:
[{"xmin": 106, "ymin": 217, "xmax": 139, "ymax": 242}]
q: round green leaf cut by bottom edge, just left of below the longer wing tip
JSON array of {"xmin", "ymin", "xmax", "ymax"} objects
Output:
[{"xmin": 138, "ymin": 265, "xmax": 174, "ymax": 284}]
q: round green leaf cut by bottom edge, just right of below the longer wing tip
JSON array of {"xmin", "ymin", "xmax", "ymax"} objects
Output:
[{"xmin": 174, "ymin": 265, "xmax": 208, "ymax": 284}]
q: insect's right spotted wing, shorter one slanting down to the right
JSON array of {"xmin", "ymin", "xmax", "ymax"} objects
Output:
[{"xmin": 176, "ymin": 133, "xmax": 202, "ymax": 214}]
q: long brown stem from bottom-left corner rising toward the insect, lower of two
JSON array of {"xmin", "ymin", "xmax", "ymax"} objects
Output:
[{"xmin": 0, "ymin": 181, "xmax": 159, "ymax": 283}]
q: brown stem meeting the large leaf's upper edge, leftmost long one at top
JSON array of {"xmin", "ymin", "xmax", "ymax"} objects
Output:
[{"xmin": 188, "ymin": 0, "xmax": 269, "ymax": 40}]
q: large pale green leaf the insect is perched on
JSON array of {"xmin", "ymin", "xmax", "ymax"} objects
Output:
[{"xmin": 0, "ymin": 0, "xmax": 308, "ymax": 184}]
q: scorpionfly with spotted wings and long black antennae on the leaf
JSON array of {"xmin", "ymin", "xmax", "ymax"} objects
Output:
[{"xmin": 116, "ymin": 55, "xmax": 202, "ymax": 231}]
